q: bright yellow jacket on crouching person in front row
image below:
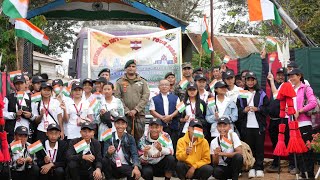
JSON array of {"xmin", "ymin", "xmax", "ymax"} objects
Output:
[{"xmin": 176, "ymin": 132, "xmax": 210, "ymax": 169}]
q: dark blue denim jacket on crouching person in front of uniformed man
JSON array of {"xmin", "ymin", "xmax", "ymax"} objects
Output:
[{"xmin": 103, "ymin": 132, "xmax": 141, "ymax": 169}]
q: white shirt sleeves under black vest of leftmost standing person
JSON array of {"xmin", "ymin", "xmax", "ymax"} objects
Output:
[{"xmin": 3, "ymin": 97, "xmax": 30, "ymax": 133}]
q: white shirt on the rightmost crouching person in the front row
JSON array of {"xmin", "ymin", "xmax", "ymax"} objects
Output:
[{"xmin": 210, "ymin": 132, "xmax": 241, "ymax": 166}]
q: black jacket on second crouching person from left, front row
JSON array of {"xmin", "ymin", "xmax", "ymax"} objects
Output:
[{"xmin": 36, "ymin": 140, "xmax": 68, "ymax": 168}]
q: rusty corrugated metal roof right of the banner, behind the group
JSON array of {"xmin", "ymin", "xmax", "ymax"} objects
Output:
[{"xmin": 188, "ymin": 33, "xmax": 265, "ymax": 59}]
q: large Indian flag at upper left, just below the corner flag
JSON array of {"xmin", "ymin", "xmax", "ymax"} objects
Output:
[{"xmin": 15, "ymin": 18, "xmax": 44, "ymax": 47}]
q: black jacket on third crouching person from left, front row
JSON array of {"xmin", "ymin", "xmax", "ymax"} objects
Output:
[{"xmin": 67, "ymin": 138, "xmax": 102, "ymax": 169}]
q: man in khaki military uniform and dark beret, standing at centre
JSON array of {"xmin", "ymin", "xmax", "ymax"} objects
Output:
[{"xmin": 115, "ymin": 60, "xmax": 150, "ymax": 142}]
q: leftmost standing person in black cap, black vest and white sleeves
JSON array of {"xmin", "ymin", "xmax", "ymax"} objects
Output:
[{"xmin": 3, "ymin": 74, "xmax": 34, "ymax": 142}]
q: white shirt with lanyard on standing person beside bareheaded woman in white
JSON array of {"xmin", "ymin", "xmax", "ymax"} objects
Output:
[{"xmin": 64, "ymin": 100, "xmax": 93, "ymax": 139}]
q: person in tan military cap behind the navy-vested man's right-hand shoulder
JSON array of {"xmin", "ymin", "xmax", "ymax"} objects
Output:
[{"xmin": 174, "ymin": 62, "xmax": 194, "ymax": 101}]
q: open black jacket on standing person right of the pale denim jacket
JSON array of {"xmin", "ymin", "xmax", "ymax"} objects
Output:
[{"xmin": 236, "ymin": 90, "xmax": 269, "ymax": 138}]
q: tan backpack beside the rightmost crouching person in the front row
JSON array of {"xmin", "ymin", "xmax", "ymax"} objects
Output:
[{"xmin": 229, "ymin": 132, "xmax": 256, "ymax": 171}]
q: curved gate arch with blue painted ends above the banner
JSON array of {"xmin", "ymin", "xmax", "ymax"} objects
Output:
[{"xmin": 27, "ymin": 0, "xmax": 188, "ymax": 30}]
